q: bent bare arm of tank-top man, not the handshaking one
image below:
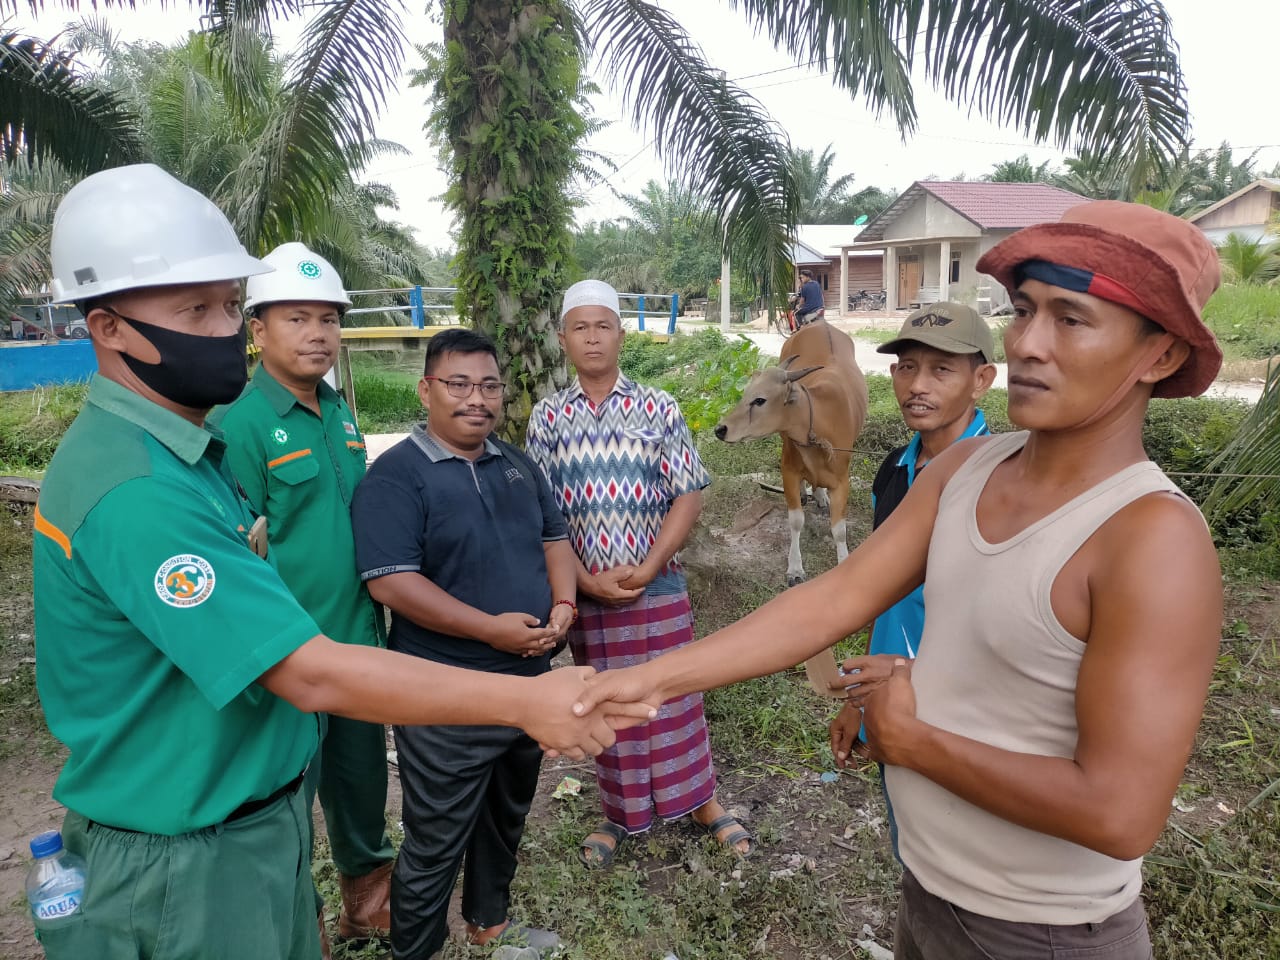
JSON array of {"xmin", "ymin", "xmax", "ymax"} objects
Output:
[{"xmin": 865, "ymin": 497, "xmax": 1222, "ymax": 859}]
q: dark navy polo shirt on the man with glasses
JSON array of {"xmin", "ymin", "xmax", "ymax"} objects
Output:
[{"xmin": 351, "ymin": 426, "xmax": 568, "ymax": 676}]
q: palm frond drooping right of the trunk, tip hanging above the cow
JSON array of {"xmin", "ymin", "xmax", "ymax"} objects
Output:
[{"xmin": 581, "ymin": 0, "xmax": 799, "ymax": 304}]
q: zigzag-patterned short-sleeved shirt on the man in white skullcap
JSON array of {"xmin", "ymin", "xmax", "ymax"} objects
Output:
[{"xmin": 526, "ymin": 374, "xmax": 712, "ymax": 595}]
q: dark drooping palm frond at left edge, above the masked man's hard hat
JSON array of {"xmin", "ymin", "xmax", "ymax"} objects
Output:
[{"xmin": 0, "ymin": 32, "xmax": 142, "ymax": 174}]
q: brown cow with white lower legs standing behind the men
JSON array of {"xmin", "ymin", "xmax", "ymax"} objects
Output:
[{"xmin": 716, "ymin": 320, "xmax": 867, "ymax": 586}]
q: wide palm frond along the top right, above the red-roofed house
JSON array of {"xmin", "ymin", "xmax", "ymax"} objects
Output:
[{"xmin": 730, "ymin": 0, "xmax": 1189, "ymax": 173}]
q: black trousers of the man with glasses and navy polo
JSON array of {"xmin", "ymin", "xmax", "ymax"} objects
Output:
[{"xmin": 392, "ymin": 727, "xmax": 543, "ymax": 960}]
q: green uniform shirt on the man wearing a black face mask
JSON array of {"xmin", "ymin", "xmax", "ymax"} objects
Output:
[{"xmin": 35, "ymin": 376, "xmax": 320, "ymax": 835}]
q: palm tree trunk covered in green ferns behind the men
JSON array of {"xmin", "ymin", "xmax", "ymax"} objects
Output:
[{"xmin": 433, "ymin": 0, "xmax": 586, "ymax": 438}]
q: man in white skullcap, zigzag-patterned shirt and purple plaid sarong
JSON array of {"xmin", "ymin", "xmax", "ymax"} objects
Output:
[{"xmin": 526, "ymin": 280, "xmax": 753, "ymax": 869}]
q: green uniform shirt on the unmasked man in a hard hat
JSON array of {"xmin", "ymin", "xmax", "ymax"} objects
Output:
[{"xmin": 210, "ymin": 365, "xmax": 385, "ymax": 645}]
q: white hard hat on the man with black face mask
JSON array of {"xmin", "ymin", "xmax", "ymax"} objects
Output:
[{"xmin": 50, "ymin": 164, "xmax": 271, "ymax": 303}]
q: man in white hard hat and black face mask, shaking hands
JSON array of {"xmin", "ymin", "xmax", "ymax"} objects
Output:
[{"xmin": 33, "ymin": 164, "xmax": 650, "ymax": 960}]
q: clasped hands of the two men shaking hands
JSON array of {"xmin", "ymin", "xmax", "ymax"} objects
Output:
[{"xmin": 520, "ymin": 667, "xmax": 667, "ymax": 760}]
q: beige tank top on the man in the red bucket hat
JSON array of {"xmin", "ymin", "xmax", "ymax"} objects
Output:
[{"xmin": 884, "ymin": 433, "xmax": 1181, "ymax": 924}]
